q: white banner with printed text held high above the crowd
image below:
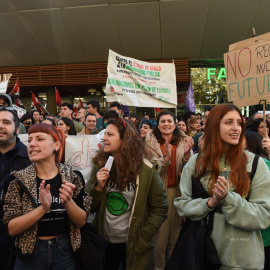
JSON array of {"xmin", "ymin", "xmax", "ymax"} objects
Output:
[{"xmin": 105, "ymin": 50, "xmax": 177, "ymax": 108}]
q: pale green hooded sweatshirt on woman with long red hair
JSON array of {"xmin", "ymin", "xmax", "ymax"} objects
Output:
[{"xmin": 174, "ymin": 151, "xmax": 270, "ymax": 270}]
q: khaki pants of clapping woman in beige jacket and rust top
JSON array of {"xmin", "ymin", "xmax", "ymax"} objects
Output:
[{"xmin": 153, "ymin": 187, "xmax": 183, "ymax": 270}]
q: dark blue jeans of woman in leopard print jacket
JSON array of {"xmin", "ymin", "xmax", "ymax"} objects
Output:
[{"xmin": 14, "ymin": 235, "xmax": 76, "ymax": 270}]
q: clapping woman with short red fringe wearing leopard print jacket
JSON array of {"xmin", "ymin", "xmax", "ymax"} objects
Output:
[{"xmin": 3, "ymin": 124, "xmax": 90, "ymax": 270}]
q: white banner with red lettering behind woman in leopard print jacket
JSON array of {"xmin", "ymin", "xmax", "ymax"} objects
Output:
[{"xmin": 19, "ymin": 129, "xmax": 105, "ymax": 182}]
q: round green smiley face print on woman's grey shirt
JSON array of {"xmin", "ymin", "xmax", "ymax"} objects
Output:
[{"xmin": 106, "ymin": 192, "xmax": 128, "ymax": 216}]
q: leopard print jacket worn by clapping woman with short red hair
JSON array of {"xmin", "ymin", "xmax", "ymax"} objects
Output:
[{"xmin": 3, "ymin": 164, "xmax": 91, "ymax": 255}]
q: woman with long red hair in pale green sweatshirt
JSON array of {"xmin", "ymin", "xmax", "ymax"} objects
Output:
[{"xmin": 172, "ymin": 104, "xmax": 270, "ymax": 270}]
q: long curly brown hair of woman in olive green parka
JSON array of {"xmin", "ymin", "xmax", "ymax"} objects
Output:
[{"xmin": 92, "ymin": 118, "xmax": 146, "ymax": 190}]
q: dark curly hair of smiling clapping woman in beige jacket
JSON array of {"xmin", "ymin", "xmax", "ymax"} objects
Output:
[{"xmin": 153, "ymin": 111, "xmax": 184, "ymax": 145}]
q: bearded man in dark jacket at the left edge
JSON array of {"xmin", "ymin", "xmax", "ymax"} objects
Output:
[{"xmin": 0, "ymin": 106, "xmax": 31, "ymax": 270}]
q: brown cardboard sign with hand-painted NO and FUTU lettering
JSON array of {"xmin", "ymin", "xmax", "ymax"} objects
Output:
[{"xmin": 224, "ymin": 33, "xmax": 270, "ymax": 107}]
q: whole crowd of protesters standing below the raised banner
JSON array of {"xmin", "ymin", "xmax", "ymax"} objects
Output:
[{"xmin": 0, "ymin": 91, "xmax": 270, "ymax": 270}]
